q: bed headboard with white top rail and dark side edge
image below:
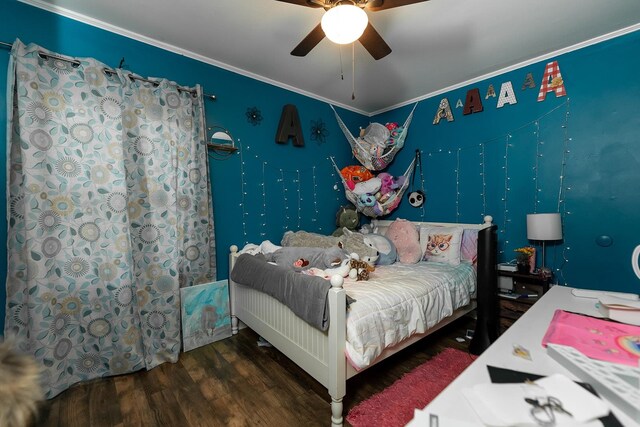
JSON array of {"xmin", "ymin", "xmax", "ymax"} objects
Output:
[{"xmin": 371, "ymin": 215, "xmax": 498, "ymax": 354}]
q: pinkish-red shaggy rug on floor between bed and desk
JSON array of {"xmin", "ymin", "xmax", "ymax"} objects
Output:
[{"xmin": 347, "ymin": 348, "xmax": 475, "ymax": 427}]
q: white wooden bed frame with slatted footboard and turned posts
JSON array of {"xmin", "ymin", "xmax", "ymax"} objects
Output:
[{"xmin": 229, "ymin": 216, "xmax": 492, "ymax": 426}]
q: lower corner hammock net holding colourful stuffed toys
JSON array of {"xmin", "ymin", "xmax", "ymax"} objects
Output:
[{"xmin": 330, "ymin": 157, "xmax": 416, "ymax": 218}]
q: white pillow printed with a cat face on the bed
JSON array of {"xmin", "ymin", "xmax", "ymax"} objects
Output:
[{"xmin": 420, "ymin": 225, "xmax": 464, "ymax": 265}]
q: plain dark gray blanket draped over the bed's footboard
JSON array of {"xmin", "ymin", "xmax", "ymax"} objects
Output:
[{"xmin": 231, "ymin": 254, "xmax": 331, "ymax": 331}]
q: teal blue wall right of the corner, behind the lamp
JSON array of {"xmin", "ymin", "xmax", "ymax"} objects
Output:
[{"xmin": 373, "ymin": 32, "xmax": 640, "ymax": 293}]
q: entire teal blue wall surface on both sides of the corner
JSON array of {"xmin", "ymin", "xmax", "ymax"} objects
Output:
[{"xmin": 0, "ymin": 0, "xmax": 640, "ymax": 332}]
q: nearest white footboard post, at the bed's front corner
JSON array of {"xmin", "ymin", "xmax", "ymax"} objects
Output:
[{"xmin": 327, "ymin": 275, "xmax": 347, "ymax": 427}]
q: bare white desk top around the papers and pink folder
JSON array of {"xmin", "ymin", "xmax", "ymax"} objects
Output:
[{"xmin": 416, "ymin": 286, "xmax": 640, "ymax": 427}]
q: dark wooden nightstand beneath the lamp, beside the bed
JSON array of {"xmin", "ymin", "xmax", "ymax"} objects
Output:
[{"xmin": 498, "ymin": 270, "xmax": 550, "ymax": 334}]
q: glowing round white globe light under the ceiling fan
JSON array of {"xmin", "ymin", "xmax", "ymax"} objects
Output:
[{"xmin": 320, "ymin": 4, "xmax": 369, "ymax": 44}]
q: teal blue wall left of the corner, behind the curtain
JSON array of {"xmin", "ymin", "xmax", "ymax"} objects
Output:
[{"xmin": 0, "ymin": 0, "xmax": 364, "ymax": 332}]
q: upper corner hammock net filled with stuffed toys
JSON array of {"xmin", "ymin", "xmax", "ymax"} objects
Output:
[{"xmin": 331, "ymin": 102, "xmax": 418, "ymax": 171}]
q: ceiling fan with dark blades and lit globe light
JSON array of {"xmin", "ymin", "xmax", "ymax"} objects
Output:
[{"xmin": 277, "ymin": 0, "xmax": 427, "ymax": 60}]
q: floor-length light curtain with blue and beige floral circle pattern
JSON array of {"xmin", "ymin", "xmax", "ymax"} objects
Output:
[{"xmin": 5, "ymin": 41, "xmax": 216, "ymax": 397}]
